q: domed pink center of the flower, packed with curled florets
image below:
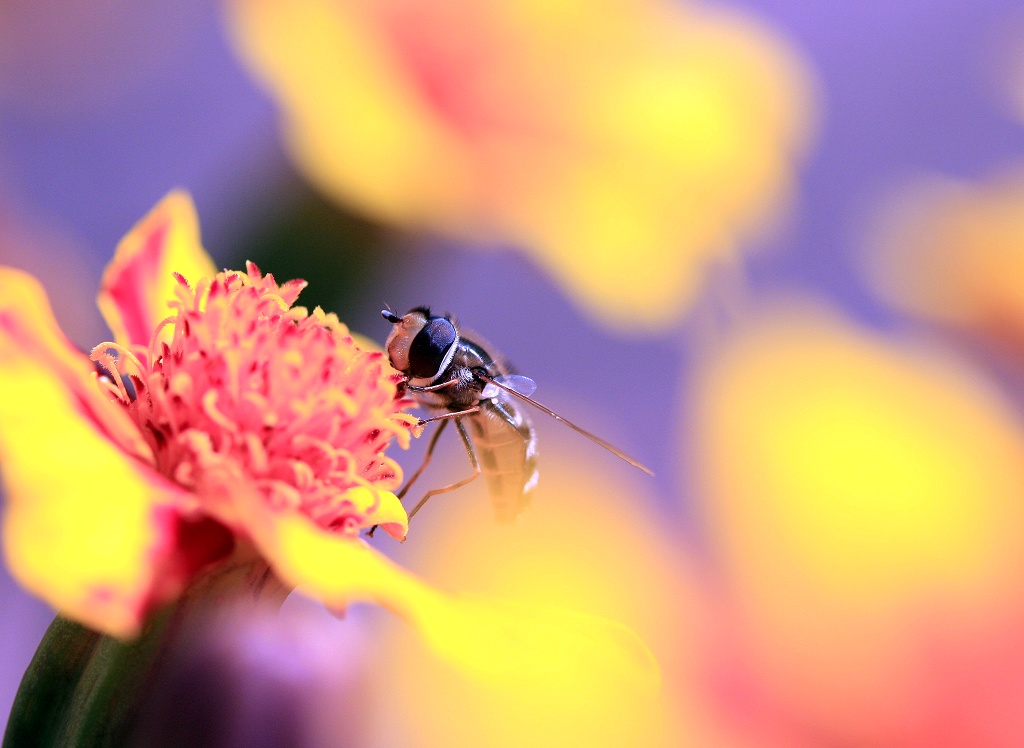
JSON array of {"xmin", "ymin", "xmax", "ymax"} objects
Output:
[{"xmin": 93, "ymin": 263, "xmax": 415, "ymax": 534}]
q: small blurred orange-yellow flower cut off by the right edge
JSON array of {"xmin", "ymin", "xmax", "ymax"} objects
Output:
[{"xmin": 868, "ymin": 167, "xmax": 1024, "ymax": 351}]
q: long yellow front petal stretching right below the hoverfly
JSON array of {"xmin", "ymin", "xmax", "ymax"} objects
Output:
[{"xmin": 250, "ymin": 507, "xmax": 659, "ymax": 698}]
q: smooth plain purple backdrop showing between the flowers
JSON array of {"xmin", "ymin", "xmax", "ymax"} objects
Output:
[{"xmin": 0, "ymin": 0, "xmax": 1024, "ymax": 719}]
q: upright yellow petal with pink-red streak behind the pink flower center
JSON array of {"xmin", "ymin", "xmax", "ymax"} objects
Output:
[{"xmin": 96, "ymin": 191, "xmax": 216, "ymax": 345}]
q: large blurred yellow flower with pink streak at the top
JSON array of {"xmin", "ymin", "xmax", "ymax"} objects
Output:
[{"xmin": 228, "ymin": 0, "xmax": 810, "ymax": 329}]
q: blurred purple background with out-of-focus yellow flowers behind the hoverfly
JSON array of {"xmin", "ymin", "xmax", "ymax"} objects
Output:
[{"xmin": 6, "ymin": 0, "xmax": 1024, "ymax": 746}]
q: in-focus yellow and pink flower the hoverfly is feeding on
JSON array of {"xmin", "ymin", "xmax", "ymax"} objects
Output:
[{"xmin": 0, "ymin": 193, "xmax": 658, "ymax": 721}]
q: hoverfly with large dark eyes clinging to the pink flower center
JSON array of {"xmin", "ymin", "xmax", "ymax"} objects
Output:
[{"xmin": 371, "ymin": 306, "xmax": 654, "ymax": 533}]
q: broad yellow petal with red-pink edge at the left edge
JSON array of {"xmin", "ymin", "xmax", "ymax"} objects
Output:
[{"xmin": 0, "ymin": 305, "xmax": 193, "ymax": 637}]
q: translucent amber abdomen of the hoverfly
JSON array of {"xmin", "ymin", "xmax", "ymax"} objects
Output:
[{"xmin": 467, "ymin": 399, "xmax": 537, "ymax": 522}]
